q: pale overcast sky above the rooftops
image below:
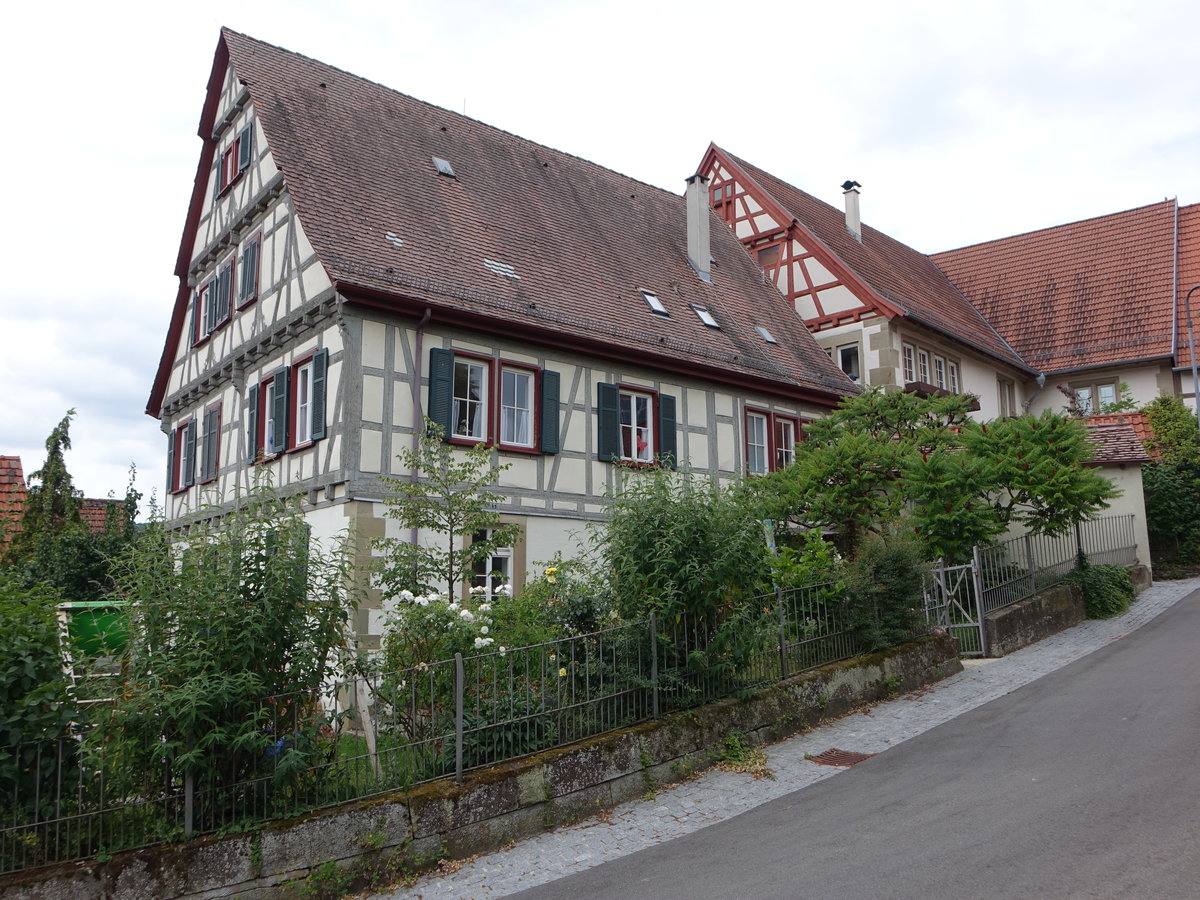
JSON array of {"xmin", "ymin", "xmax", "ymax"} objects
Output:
[{"xmin": 0, "ymin": 0, "xmax": 1200, "ymax": 497}]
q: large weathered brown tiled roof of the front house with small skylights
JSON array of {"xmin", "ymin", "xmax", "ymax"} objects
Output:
[{"xmin": 217, "ymin": 30, "xmax": 856, "ymax": 402}]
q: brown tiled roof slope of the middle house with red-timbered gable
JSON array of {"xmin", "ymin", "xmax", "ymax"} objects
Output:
[{"xmin": 721, "ymin": 150, "xmax": 1027, "ymax": 368}]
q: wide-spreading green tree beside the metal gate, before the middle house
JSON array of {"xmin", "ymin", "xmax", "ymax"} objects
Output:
[{"xmin": 754, "ymin": 389, "xmax": 1115, "ymax": 559}]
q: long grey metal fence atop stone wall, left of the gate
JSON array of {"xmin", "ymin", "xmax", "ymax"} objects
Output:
[{"xmin": 0, "ymin": 584, "xmax": 862, "ymax": 874}]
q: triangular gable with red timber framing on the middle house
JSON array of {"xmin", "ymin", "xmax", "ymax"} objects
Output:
[{"xmin": 700, "ymin": 145, "xmax": 901, "ymax": 331}]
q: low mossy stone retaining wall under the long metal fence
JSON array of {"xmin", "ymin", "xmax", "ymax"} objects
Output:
[{"xmin": 0, "ymin": 636, "xmax": 962, "ymax": 900}]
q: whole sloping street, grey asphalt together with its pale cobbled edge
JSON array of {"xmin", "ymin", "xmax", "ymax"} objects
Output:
[{"xmin": 385, "ymin": 580, "xmax": 1200, "ymax": 899}]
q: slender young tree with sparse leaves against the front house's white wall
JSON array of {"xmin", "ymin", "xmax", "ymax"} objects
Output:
[{"xmin": 373, "ymin": 419, "xmax": 521, "ymax": 596}]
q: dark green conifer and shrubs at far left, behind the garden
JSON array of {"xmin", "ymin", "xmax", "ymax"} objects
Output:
[{"xmin": 4, "ymin": 409, "xmax": 142, "ymax": 601}]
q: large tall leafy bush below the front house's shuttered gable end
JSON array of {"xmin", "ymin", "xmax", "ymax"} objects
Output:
[{"xmin": 98, "ymin": 490, "xmax": 355, "ymax": 821}]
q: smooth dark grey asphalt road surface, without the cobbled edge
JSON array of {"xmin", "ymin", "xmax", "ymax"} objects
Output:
[{"xmin": 515, "ymin": 594, "xmax": 1200, "ymax": 900}]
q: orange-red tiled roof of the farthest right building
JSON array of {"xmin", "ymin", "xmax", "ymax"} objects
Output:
[{"xmin": 932, "ymin": 200, "xmax": 1176, "ymax": 372}]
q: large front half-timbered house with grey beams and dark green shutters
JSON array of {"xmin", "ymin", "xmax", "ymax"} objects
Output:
[{"xmin": 148, "ymin": 30, "xmax": 856, "ymax": 646}]
